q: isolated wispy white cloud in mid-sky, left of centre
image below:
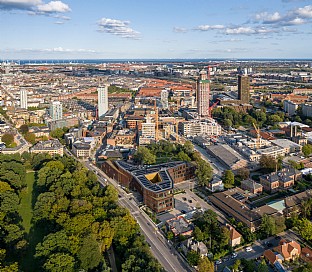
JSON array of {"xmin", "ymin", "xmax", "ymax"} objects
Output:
[{"xmin": 97, "ymin": 18, "xmax": 141, "ymax": 39}]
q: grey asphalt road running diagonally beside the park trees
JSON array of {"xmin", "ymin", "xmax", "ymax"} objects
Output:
[{"xmin": 85, "ymin": 162, "xmax": 192, "ymax": 272}]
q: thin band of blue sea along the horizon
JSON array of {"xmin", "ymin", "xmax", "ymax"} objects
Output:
[{"xmin": 0, "ymin": 58, "xmax": 312, "ymax": 65}]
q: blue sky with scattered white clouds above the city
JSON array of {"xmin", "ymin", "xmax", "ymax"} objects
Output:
[{"xmin": 0, "ymin": 0, "xmax": 312, "ymax": 60}]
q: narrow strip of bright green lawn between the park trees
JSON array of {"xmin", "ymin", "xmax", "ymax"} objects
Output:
[{"xmin": 19, "ymin": 172, "xmax": 35, "ymax": 234}]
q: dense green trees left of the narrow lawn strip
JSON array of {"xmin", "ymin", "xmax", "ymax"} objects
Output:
[{"xmin": 0, "ymin": 154, "xmax": 27, "ymax": 272}]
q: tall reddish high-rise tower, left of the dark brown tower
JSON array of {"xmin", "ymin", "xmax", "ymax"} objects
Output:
[{"xmin": 196, "ymin": 71, "xmax": 210, "ymax": 117}]
